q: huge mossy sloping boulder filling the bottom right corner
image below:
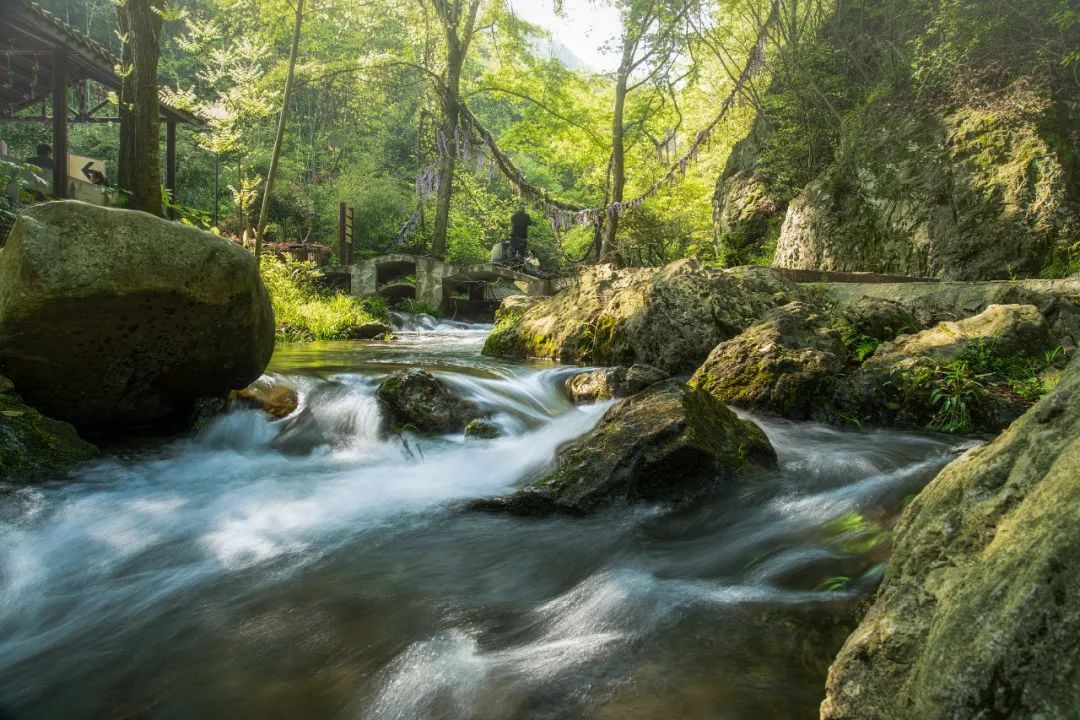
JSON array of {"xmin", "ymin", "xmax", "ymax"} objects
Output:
[{"xmin": 821, "ymin": 362, "xmax": 1080, "ymax": 720}]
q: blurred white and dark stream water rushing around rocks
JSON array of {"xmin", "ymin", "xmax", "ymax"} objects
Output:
[{"xmin": 0, "ymin": 321, "xmax": 972, "ymax": 720}]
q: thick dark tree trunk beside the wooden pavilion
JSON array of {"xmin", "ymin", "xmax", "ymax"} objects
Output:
[{"xmin": 117, "ymin": 0, "xmax": 164, "ymax": 215}]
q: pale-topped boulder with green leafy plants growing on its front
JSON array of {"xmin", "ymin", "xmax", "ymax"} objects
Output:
[{"xmin": 834, "ymin": 305, "xmax": 1051, "ymax": 432}]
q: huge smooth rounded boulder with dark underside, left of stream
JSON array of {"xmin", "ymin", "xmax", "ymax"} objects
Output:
[{"xmin": 0, "ymin": 201, "xmax": 274, "ymax": 431}]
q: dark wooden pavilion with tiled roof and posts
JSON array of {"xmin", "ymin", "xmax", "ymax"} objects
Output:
[{"xmin": 0, "ymin": 0, "xmax": 204, "ymax": 202}]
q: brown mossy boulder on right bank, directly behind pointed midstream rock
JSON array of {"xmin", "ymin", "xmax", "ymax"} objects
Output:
[{"xmin": 690, "ymin": 302, "xmax": 845, "ymax": 420}]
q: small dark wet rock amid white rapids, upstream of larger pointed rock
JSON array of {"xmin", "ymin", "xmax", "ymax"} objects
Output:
[{"xmin": 375, "ymin": 368, "xmax": 478, "ymax": 434}]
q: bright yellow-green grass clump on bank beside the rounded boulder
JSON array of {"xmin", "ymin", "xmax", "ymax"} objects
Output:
[{"xmin": 261, "ymin": 254, "xmax": 389, "ymax": 342}]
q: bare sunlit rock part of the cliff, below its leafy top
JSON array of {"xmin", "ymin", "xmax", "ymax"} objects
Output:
[{"xmin": 773, "ymin": 91, "xmax": 1080, "ymax": 279}]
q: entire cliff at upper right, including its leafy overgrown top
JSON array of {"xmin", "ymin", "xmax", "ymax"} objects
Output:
[{"xmin": 714, "ymin": 0, "xmax": 1080, "ymax": 280}]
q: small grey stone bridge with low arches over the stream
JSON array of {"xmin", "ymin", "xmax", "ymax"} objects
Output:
[{"xmin": 352, "ymin": 255, "xmax": 553, "ymax": 314}]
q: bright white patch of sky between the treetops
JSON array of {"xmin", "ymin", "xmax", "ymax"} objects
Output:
[{"xmin": 510, "ymin": 0, "xmax": 621, "ymax": 72}]
